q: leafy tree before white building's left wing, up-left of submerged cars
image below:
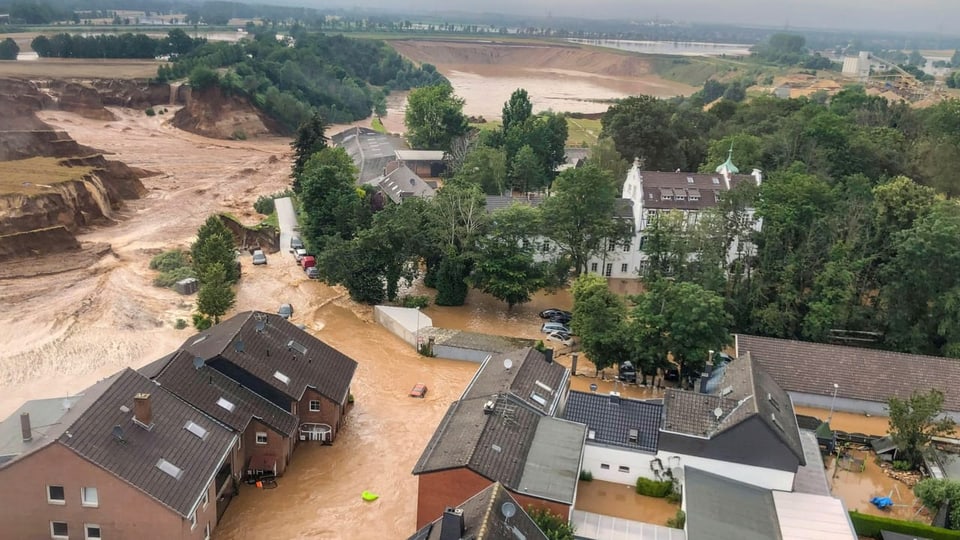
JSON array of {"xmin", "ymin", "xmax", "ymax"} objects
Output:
[{"xmin": 469, "ymin": 204, "xmax": 548, "ymax": 309}]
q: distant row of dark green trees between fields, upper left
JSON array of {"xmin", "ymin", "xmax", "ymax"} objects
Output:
[{"xmin": 30, "ymin": 29, "xmax": 207, "ymax": 59}]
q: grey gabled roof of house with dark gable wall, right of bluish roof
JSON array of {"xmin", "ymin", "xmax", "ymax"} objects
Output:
[{"xmin": 663, "ymin": 354, "xmax": 805, "ymax": 464}]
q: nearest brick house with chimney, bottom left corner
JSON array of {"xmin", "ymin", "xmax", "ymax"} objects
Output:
[{"xmin": 0, "ymin": 369, "xmax": 238, "ymax": 540}]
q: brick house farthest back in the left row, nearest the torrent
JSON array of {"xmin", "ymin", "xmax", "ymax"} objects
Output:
[{"xmin": 181, "ymin": 311, "xmax": 357, "ymax": 443}]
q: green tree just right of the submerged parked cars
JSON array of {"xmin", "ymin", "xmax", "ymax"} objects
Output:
[{"xmin": 570, "ymin": 274, "xmax": 633, "ymax": 374}]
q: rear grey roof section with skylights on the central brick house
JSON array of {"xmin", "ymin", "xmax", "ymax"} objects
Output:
[{"xmin": 462, "ymin": 348, "xmax": 570, "ymax": 414}]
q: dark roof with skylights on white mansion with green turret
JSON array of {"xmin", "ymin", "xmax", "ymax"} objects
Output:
[{"xmin": 640, "ymin": 171, "xmax": 756, "ymax": 210}]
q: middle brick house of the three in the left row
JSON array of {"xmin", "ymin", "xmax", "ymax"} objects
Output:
[{"xmin": 140, "ymin": 350, "xmax": 299, "ymax": 475}]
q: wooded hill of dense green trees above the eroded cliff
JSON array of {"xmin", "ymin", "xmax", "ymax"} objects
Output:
[{"xmin": 157, "ymin": 29, "xmax": 446, "ymax": 132}]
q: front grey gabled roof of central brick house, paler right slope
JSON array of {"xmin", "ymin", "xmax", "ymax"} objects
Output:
[{"xmin": 413, "ymin": 393, "xmax": 586, "ymax": 504}]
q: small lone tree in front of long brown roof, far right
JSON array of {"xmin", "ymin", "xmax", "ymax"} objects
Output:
[{"xmin": 887, "ymin": 388, "xmax": 956, "ymax": 467}]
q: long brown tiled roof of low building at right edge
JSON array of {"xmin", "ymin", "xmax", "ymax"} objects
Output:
[{"xmin": 736, "ymin": 334, "xmax": 960, "ymax": 412}]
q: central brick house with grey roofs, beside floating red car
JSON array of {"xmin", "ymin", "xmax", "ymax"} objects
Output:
[{"xmin": 413, "ymin": 349, "xmax": 586, "ymax": 529}]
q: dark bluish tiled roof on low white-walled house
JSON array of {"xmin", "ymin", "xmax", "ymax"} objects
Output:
[{"xmin": 563, "ymin": 390, "xmax": 663, "ymax": 452}]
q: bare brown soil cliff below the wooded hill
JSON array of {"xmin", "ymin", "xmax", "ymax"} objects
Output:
[{"xmin": 173, "ymin": 87, "xmax": 282, "ymax": 139}]
